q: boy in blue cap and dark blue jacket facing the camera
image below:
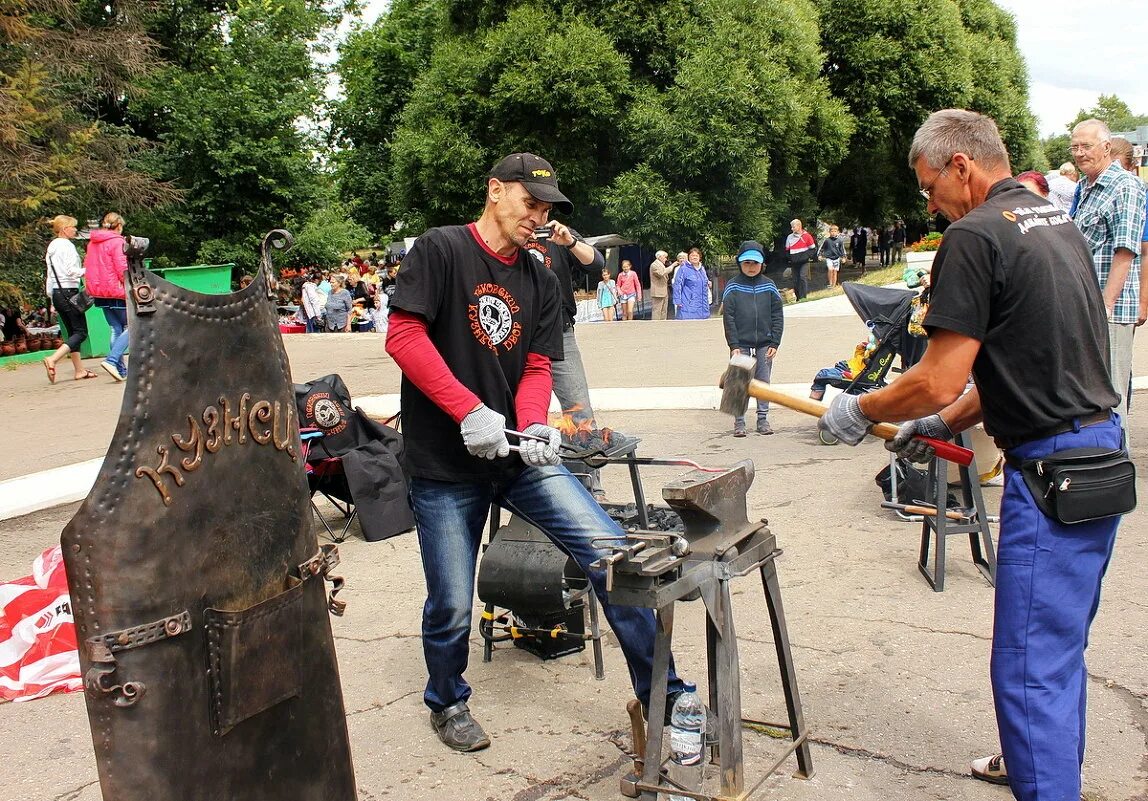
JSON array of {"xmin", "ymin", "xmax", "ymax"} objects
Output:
[{"xmin": 722, "ymin": 240, "xmax": 785, "ymax": 437}]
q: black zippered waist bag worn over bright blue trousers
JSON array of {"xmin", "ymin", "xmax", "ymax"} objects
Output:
[{"xmin": 1021, "ymin": 448, "xmax": 1137, "ymax": 523}]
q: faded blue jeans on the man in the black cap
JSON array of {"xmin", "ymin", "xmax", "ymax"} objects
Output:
[{"xmin": 410, "ymin": 467, "xmax": 682, "ymax": 711}]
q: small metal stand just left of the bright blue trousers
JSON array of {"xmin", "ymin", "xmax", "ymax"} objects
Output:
[{"xmin": 917, "ymin": 431, "xmax": 996, "ymax": 592}]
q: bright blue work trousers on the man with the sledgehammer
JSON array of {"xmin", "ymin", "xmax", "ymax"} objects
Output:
[{"xmin": 991, "ymin": 415, "xmax": 1120, "ymax": 801}]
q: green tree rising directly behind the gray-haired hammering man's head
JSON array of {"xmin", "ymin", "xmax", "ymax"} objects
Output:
[{"xmin": 817, "ymin": 0, "xmax": 1038, "ymax": 224}]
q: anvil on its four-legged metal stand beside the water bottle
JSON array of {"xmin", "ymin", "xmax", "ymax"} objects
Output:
[{"xmin": 607, "ymin": 461, "xmax": 813, "ymax": 801}]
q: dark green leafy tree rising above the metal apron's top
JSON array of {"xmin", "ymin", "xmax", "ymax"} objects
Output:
[{"xmin": 123, "ymin": 0, "xmax": 340, "ymax": 270}]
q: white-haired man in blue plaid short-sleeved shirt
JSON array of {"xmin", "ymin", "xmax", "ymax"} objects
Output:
[{"xmin": 1069, "ymin": 119, "xmax": 1145, "ymax": 441}]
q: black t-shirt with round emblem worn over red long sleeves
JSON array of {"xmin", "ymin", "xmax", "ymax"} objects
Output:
[{"xmin": 390, "ymin": 225, "xmax": 563, "ymax": 481}]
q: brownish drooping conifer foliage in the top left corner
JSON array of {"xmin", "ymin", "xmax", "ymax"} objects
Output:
[{"xmin": 0, "ymin": 0, "xmax": 174, "ymax": 290}]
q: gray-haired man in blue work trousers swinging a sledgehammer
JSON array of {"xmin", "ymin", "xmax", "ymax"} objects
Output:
[{"xmin": 819, "ymin": 109, "xmax": 1122, "ymax": 801}]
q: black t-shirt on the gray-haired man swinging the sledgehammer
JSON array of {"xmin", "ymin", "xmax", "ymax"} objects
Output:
[{"xmin": 925, "ymin": 178, "xmax": 1117, "ymax": 448}]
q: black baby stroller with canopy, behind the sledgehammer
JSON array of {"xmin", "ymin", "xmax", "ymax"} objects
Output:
[{"xmin": 810, "ymin": 282, "xmax": 928, "ymax": 445}]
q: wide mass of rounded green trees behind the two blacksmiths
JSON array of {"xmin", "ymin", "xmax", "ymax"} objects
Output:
[{"xmin": 335, "ymin": 0, "xmax": 1045, "ymax": 248}]
